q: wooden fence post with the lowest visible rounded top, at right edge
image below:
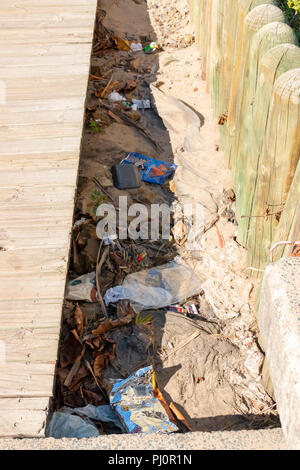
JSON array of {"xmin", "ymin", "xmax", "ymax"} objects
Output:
[{"xmin": 247, "ymin": 68, "xmax": 300, "ymax": 272}]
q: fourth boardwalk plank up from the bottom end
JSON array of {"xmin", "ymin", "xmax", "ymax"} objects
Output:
[{"xmin": 0, "ymin": 299, "xmax": 62, "ymax": 330}]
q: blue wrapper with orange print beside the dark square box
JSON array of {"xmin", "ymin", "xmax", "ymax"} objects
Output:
[{"xmin": 121, "ymin": 152, "xmax": 177, "ymax": 184}]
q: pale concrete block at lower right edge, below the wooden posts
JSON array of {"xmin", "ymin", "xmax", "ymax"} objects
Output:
[{"xmin": 258, "ymin": 258, "xmax": 300, "ymax": 450}]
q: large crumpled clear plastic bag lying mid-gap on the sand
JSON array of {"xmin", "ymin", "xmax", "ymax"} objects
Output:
[{"xmin": 104, "ymin": 260, "xmax": 201, "ymax": 311}]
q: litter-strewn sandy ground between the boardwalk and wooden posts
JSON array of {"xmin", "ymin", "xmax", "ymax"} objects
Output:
[{"xmin": 51, "ymin": 0, "xmax": 278, "ymax": 431}]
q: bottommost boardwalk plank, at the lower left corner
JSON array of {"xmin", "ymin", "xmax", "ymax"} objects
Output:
[{"xmin": 0, "ymin": 397, "xmax": 49, "ymax": 437}]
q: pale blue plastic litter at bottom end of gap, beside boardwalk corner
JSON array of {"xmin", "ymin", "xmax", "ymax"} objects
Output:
[{"xmin": 47, "ymin": 411, "xmax": 100, "ymax": 439}]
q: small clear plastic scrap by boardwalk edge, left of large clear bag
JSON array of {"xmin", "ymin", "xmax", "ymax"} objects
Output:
[{"xmin": 66, "ymin": 272, "xmax": 97, "ymax": 302}]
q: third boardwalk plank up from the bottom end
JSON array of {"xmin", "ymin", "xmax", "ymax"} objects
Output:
[{"xmin": 0, "ymin": 325, "xmax": 60, "ymax": 364}]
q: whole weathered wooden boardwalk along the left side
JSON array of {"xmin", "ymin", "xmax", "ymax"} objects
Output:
[{"xmin": 0, "ymin": 0, "xmax": 96, "ymax": 436}]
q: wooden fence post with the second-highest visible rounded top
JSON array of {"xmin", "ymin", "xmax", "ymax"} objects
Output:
[{"xmin": 233, "ymin": 22, "xmax": 296, "ymax": 246}]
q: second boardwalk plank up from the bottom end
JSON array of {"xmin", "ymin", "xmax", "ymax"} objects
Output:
[{"xmin": 0, "ymin": 362, "xmax": 55, "ymax": 398}]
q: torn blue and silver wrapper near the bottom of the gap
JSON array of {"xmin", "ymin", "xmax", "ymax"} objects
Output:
[{"xmin": 110, "ymin": 366, "xmax": 178, "ymax": 434}]
